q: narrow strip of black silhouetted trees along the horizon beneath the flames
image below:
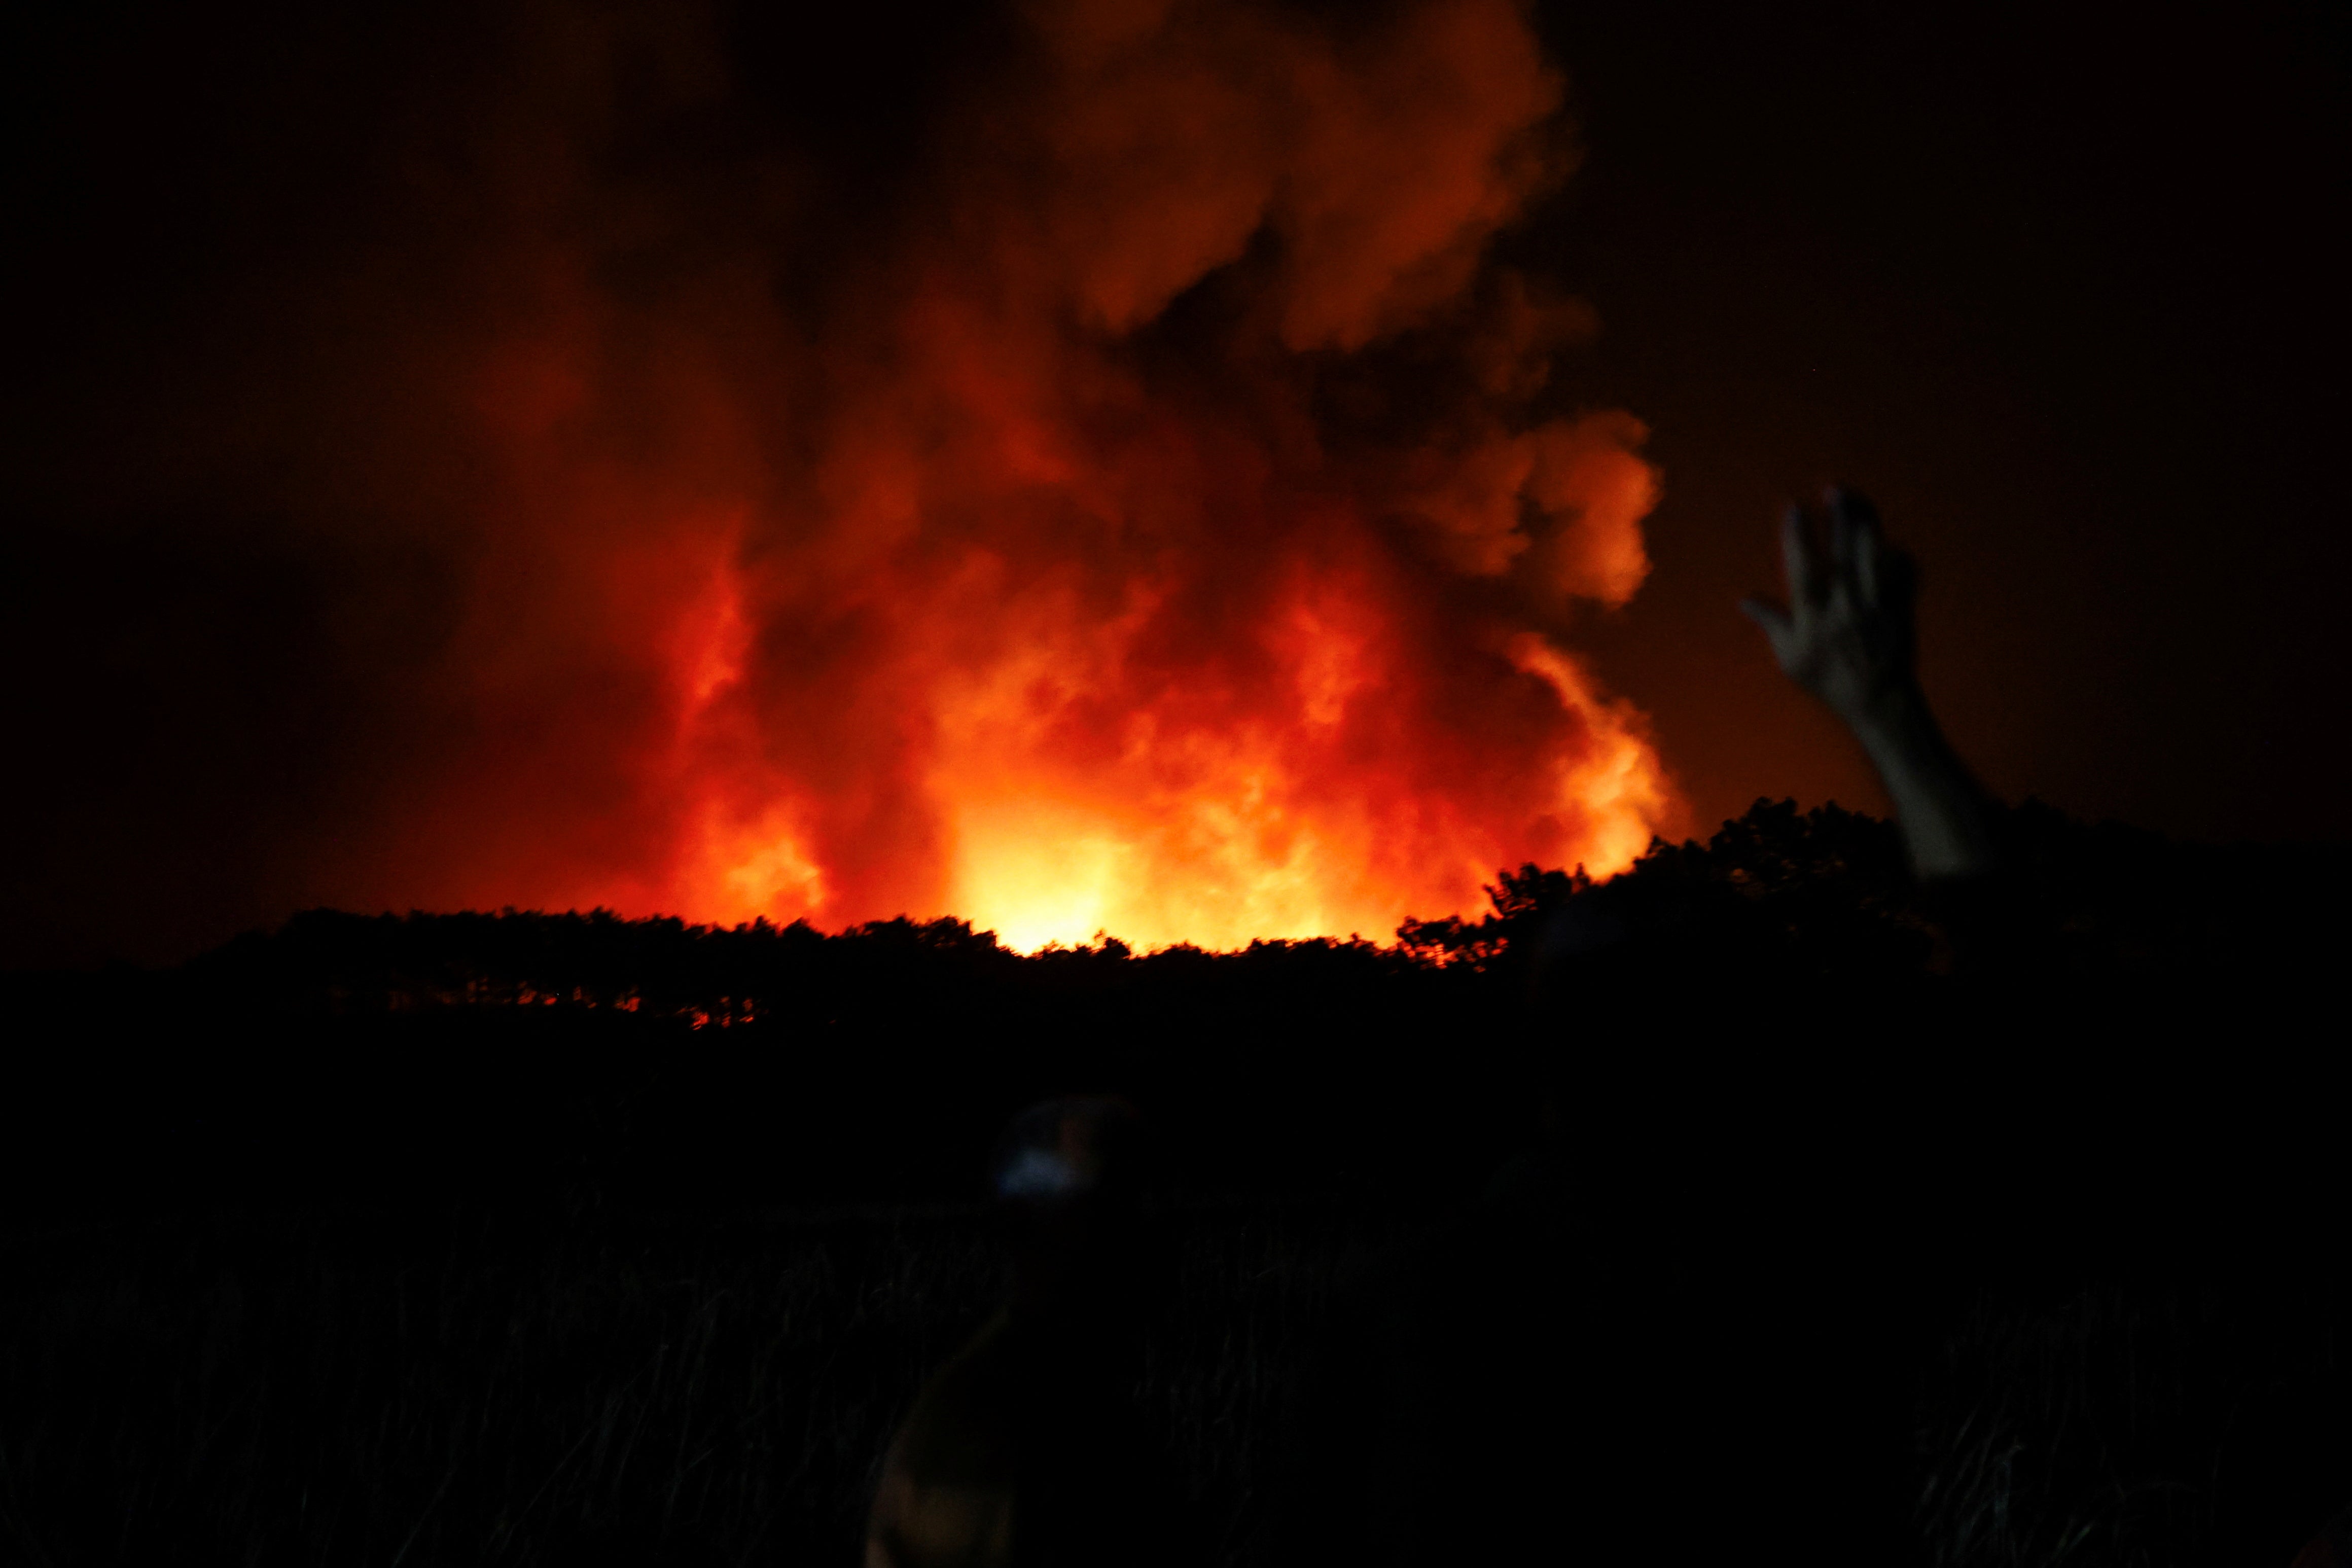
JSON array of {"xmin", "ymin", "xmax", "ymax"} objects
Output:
[{"xmin": 128, "ymin": 799, "xmax": 2352, "ymax": 1027}]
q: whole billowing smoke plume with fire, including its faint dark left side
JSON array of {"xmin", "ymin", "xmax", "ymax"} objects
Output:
[{"xmin": 19, "ymin": 0, "xmax": 1674, "ymax": 964}]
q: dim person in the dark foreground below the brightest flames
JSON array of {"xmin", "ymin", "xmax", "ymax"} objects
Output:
[{"xmin": 866, "ymin": 1098, "xmax": 1183, "ymax": 1568}]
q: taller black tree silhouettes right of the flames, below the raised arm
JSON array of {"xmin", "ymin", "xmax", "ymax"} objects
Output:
[{"xmin": 1397, "ymin": 799, "xmax": 2352, "ymax": 983}]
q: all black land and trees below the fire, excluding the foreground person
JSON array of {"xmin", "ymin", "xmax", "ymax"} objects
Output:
[{"xmin": 0, "ymin": 804, "xmax": 2352, "ymax": 1568}]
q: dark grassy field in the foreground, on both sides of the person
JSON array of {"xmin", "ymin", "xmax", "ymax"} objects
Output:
[{"xmin": 0, "ymin": 1185, "xmax": 2352, "ymax": 1568}]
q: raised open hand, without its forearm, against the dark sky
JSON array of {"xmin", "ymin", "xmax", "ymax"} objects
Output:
[{"xmin": 1740, "ymin": 487, "xmax": 1919, "ymax": 729}]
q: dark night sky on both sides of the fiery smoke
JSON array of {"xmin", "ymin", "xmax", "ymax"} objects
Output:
[{"xmin": 0, "ymin": 5, "xmax": 2352, "ymax": 961}]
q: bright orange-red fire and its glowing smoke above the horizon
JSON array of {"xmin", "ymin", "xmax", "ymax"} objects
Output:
[{"xmin": 352, "ymin": 0, "xmax": 1677, "ymax": 947}]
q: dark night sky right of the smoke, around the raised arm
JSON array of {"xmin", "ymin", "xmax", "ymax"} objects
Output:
[{"xmin": 1545, "ymin": 5, "xmax": 2352, "ymax": 842}]
